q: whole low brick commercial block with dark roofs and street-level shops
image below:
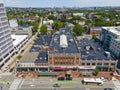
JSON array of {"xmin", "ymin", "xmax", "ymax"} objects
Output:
[{"xmin": 17, "ymin": 29, "xmax": 117, "ymax": 75}]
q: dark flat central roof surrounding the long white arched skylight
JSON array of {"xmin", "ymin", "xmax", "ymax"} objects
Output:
[{"xmin": 50, "ymin": 29, "xmax": 79, "ymax": 53}]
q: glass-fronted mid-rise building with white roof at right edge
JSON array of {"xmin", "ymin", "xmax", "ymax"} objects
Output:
[{"xmin": 100, "ymin": 26, "xmax": 120, "ymax": 58}]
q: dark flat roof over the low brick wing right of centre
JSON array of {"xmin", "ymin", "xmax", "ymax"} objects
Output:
[{"xmin": 77, "ymin": 39, "xmax": 114, "ymax": 60}]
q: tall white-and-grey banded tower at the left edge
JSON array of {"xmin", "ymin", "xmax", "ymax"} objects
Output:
[{"xmin": 0, "ymin": 2, "xmax": 14, "ymax": 68}]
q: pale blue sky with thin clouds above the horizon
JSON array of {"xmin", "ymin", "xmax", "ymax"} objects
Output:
[{"xmin": 2, "ymin": 0, "xmax": 120, "ymax": 7}]
